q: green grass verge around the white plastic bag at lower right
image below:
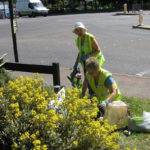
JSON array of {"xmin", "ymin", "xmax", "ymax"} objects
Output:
[{"xmin": 119, "ymin": 97, "xmax": 150, "ymax": 150}]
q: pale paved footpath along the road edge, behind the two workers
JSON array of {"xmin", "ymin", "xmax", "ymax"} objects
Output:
[{"xmin": 12, "ymin": 68, "xmax": 150, "ymax": 99}]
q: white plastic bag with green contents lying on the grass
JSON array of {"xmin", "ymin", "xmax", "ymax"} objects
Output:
[{"xmin": 128, "ymin": 111, "xmax": 150, "ymax": 133}]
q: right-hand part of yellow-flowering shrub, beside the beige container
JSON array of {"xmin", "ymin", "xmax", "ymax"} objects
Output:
[{"xmin": 58, "ymin": 89, "xmax": 119, "ymax": 149}]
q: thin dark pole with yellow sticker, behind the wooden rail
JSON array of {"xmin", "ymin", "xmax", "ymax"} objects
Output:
[{"xmin": 8, "ymin": 0, "xmax": 19, "ymax": 62}]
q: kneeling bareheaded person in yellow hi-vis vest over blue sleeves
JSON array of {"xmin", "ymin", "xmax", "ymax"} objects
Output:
[{"xmin": 82, "ymin": 58, "xmax": 121, "ymax": 115}]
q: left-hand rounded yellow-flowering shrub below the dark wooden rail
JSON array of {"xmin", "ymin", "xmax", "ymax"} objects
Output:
[{"xmin": 0, "ymin": 74, "xmax": 60, "ymax": 150}]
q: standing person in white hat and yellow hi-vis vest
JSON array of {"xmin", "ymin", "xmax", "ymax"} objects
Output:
[{"xmin": 73, "ymin": 22, "xmax": 105, "ymax": 95}]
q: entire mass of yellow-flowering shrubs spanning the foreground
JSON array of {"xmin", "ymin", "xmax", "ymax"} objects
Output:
[{"xmin": 0, "ymin": 74, "xmax": 119, "ymax": 150}]
